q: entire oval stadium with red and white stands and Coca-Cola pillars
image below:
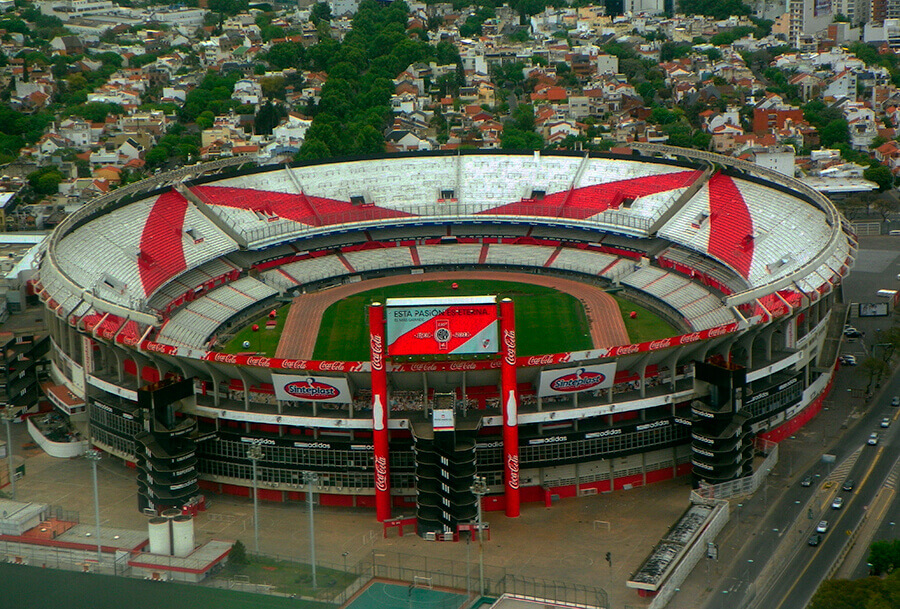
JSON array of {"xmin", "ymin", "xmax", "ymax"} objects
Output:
[{"xmin": 33, "ymin": 144, "xmax": 857, "ymax": 535}]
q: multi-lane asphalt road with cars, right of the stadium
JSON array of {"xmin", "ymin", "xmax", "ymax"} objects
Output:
[{"xmin": 697, "ymin": 376, "xmax": 900, "ymax": 609}]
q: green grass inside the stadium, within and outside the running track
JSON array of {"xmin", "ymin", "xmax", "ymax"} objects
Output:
[{"xmin": 224, "ymin": 280, "xmax": 678, "ymax": 361}]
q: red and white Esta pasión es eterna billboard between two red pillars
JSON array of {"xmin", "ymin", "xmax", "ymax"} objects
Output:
[{"xmin": 385, "ymin": 296, "xmax": 500, "ymax": 356}]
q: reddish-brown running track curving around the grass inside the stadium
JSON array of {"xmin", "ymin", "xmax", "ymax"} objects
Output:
[{"xmin": 275, "ymin": 271, "xmax": 629, "ymax": 359}]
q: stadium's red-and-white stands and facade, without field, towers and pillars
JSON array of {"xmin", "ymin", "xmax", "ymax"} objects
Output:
[{"xmin": 33, "ymin": 145, "xmax": 857, "ymax": 528}]
